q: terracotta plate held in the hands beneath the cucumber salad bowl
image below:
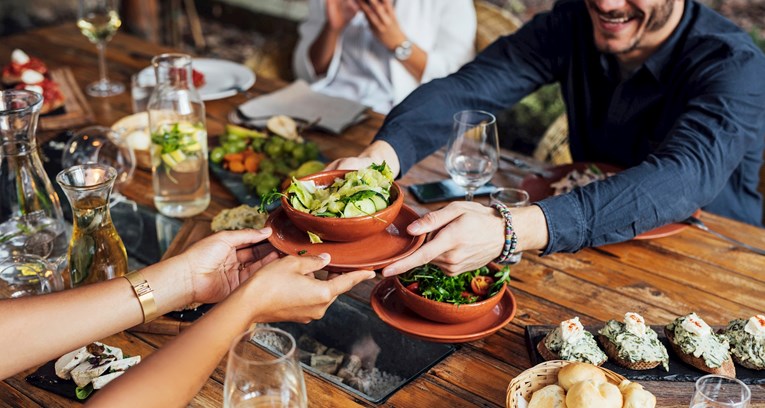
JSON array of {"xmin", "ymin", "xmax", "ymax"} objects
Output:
[{"xmin": 266, "ymin": 205, "xmax": 425, "ymax": 272}]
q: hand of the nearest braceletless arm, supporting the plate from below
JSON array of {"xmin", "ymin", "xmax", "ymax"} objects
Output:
[{"xmin": 242, "ymin": 254, "xmax": 375, "ymax": 323}]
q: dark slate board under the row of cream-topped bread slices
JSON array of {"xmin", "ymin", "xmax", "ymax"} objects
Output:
[{"xmin": 526, "ymin": 325, "xmax": 765, "ymax": 384}]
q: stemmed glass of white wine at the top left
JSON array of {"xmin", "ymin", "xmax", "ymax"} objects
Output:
[{"xmin": 77, "ymin": 0, "xmax": 125, "ymax": 97}]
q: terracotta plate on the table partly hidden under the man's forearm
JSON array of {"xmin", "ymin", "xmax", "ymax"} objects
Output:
[{"xmin": 521, "ymin": 162, "xmax": 701, "ymax": 239}]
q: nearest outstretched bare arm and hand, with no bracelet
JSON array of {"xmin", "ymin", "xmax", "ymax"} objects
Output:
[{"xmin": 89, "ymin": 254, "xmax": 374, "ymax": 407}]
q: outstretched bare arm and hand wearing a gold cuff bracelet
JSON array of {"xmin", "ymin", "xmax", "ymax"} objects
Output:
[{"xmin": 0, "ymin": 228, "xmax": 274, "ymax": 378}]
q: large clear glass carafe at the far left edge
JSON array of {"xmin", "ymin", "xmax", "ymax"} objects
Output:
[{"xmin": 0, "ymin": 90, "xmax": 66, "ymax": 260}]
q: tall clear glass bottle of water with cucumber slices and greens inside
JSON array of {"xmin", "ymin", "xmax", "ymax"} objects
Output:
[{"xmin": 147, "ymin": 54, "xmax": 210, "ymax": 217}]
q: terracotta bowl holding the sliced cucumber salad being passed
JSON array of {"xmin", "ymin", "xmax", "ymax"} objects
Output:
[{"xmin": 282, "ymin": 170, "xmax": 404, "ymax": 242}]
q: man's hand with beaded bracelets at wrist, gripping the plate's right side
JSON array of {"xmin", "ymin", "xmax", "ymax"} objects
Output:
[{"xmin": 383, "ymin": 201, "xmax": 505, "ymax": 276}]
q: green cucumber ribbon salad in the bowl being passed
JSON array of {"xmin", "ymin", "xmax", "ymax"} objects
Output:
[{"xmin": 286, "ymin": 162, "xmax": 393, "ymax": 218}]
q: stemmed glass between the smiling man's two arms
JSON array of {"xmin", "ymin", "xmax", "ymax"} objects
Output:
[{"xmin": 445, "ymin": 110, "xmax": 499, "ymax": 201}]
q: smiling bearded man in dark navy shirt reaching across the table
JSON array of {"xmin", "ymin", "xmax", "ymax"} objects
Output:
[{"xmin": 328, "ymin": 0, "xmax": 765, "ymax": 274}]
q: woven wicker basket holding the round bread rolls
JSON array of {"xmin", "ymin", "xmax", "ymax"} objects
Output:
[{"xmin": 506, "ymin": 360, "xmax": 625, "ymax": 408}]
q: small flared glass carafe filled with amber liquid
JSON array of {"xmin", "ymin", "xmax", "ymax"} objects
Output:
[{"xmin": 56, "ymin": 163, "xmax": 128, "ymax": 288}]
